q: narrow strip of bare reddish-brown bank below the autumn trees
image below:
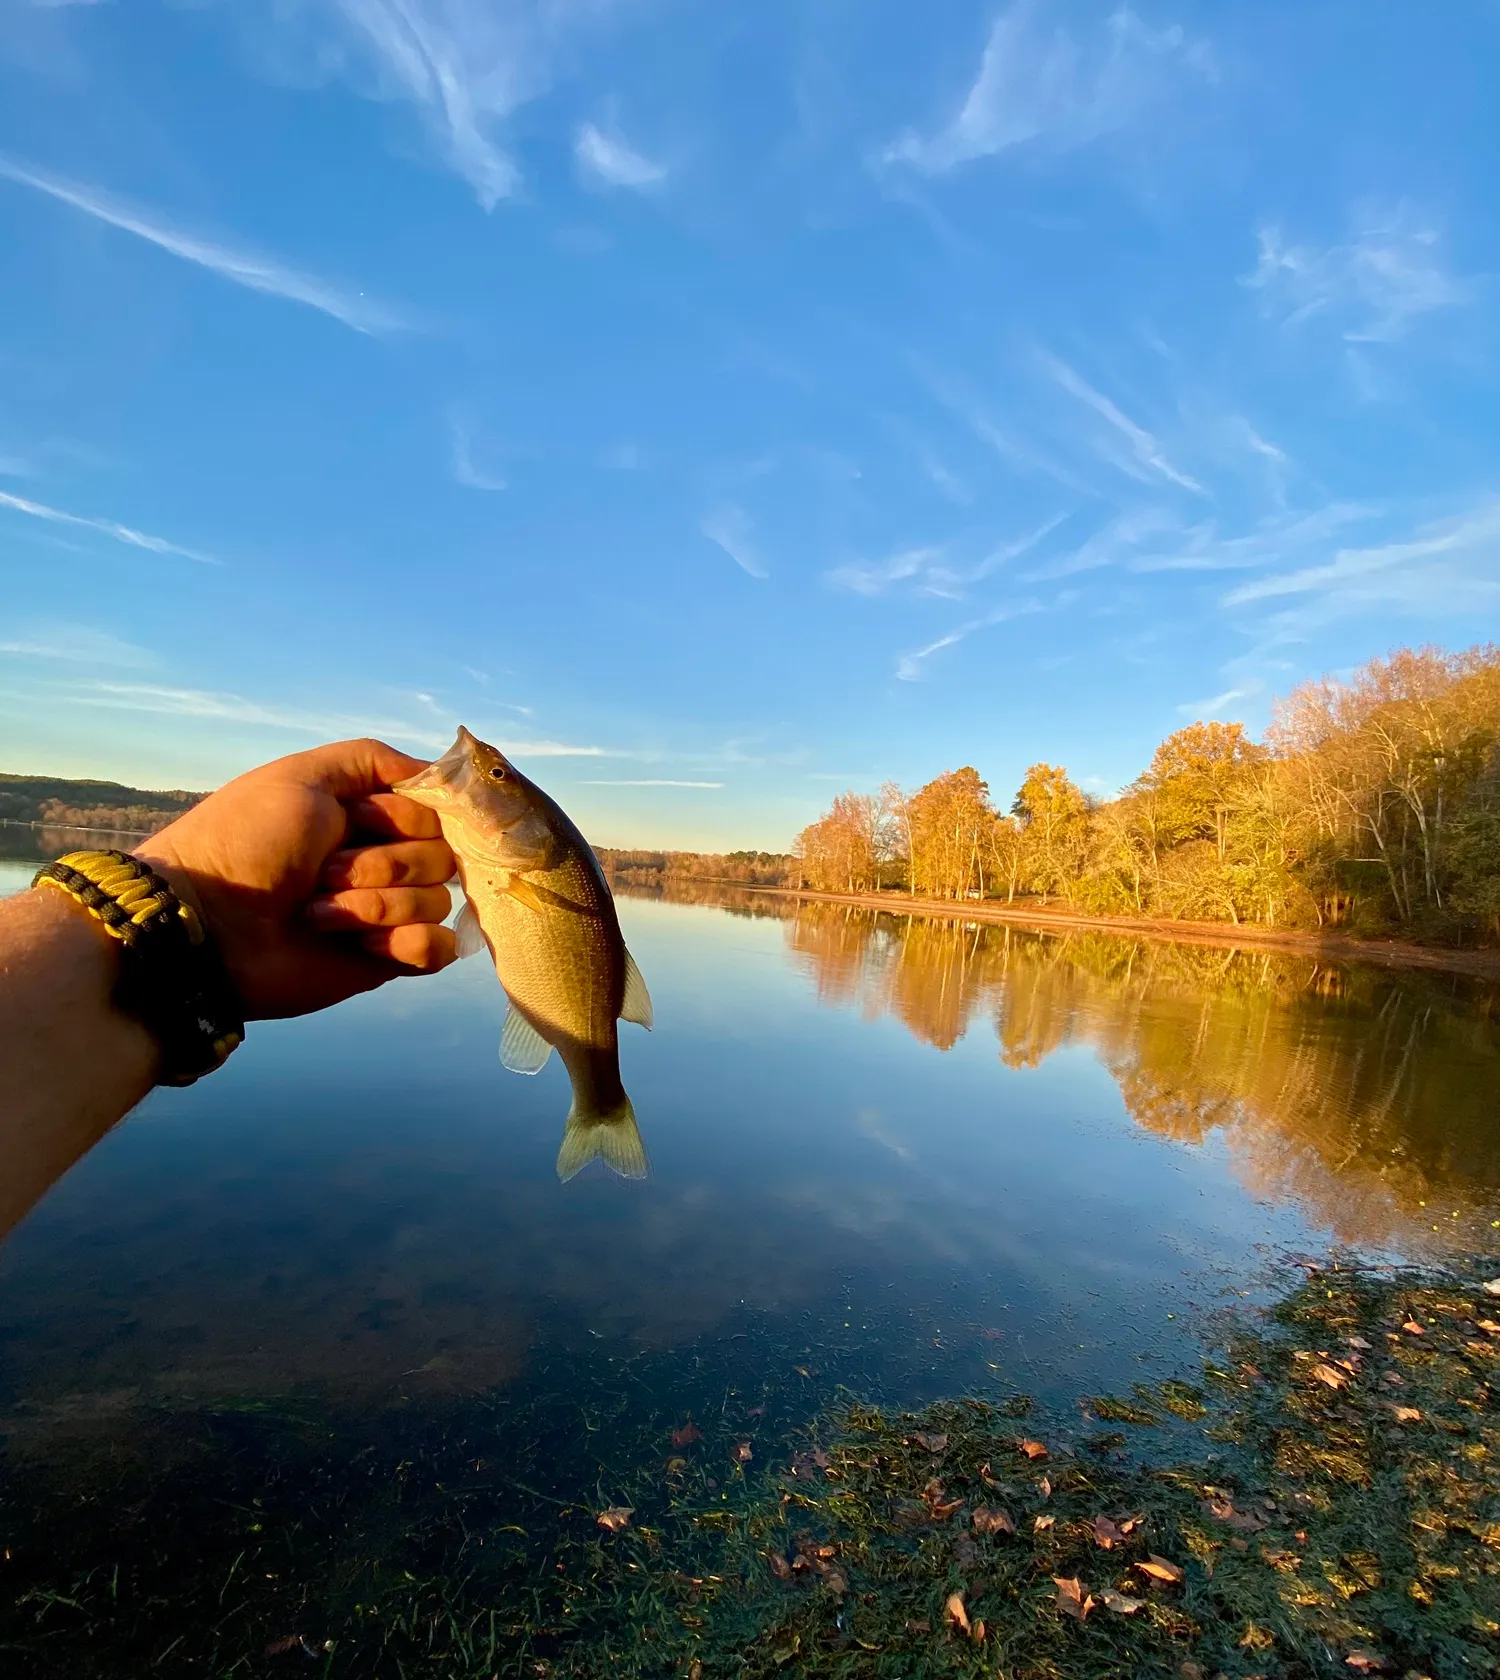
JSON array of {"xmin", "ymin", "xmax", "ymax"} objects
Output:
[{"xmin": 705, "ymin": 880, "xmax": 1500, "ymax": 979}]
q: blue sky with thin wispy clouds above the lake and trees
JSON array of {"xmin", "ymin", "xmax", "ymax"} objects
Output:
[{"xmin": 0, "ymin": 0, "xmax": 1500, "ymax": 847}]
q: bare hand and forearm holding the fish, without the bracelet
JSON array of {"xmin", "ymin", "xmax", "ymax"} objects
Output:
[{"xmin": 0, "ymin": 741, "xmax": 454, "ymax": 1235}]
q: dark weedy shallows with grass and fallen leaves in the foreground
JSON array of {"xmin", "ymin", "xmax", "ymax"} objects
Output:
[{"xmin": 0, "ymin": 1268, "xmax": 1500, "ymax": 1680}]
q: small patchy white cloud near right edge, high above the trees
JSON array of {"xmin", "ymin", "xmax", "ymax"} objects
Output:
[{"xmin": 1241, "ymin": 205, "xmax": 1473, "ymax": 344}]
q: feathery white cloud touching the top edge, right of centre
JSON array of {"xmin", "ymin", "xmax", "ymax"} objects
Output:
[{"xmin": 882, "ymin": 0, "xmax": 1213, "ymax": 175}]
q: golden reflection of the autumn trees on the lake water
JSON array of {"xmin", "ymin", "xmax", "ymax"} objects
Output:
[{"xmin": 661, "ymin": 892, "xmax": 1500, "ymax": 1250}]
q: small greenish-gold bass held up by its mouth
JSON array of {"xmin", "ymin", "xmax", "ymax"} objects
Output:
[{"xmin": 393, "ymin": 727, "xmax": 652, "ymax": 1183}]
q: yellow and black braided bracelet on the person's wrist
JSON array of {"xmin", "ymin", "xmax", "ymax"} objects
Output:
[{"xmin": 32, "ymin": 852, "xmax": 245, "ymax": 1085}]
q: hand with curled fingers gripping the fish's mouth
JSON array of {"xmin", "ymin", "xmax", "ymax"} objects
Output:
[{"xmin": 136, "ymin": 741, "xmax": 455, "ymax": 1020}]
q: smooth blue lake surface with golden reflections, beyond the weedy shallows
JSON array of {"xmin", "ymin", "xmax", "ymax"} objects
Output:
[{"xmin": 0, "ymin": 860, "xmax": 1500, "ymax": 1443}]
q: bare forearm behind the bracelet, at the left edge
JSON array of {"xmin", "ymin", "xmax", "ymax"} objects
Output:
[{"xmin": 0, "ymin": 887, "xmax": 156, "ymax": 1236}]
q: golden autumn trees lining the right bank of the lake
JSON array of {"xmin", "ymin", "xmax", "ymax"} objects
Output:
[{"xmin": 793, "ymin": 645, "xmax": 1500, "ymax": 939}]
